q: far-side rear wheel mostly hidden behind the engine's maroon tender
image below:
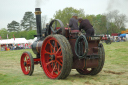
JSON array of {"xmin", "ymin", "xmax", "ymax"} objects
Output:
[{"xmin": 76, "ymin": 43, "xmax": 105, "ymax": 75}]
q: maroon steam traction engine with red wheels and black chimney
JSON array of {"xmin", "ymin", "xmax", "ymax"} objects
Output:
[{"xmin": 21, "ymin": 8, "xmax": 105, "ymax": 79}]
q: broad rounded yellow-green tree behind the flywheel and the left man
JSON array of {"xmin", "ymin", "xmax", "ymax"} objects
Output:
[{"xmin": 53, "ymin": 7, "xmax": 85, "ymax": 26}]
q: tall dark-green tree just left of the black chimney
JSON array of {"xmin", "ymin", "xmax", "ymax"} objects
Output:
[{"xmin": 21, "ymin": 12, "xmax": 36, "ymax": 31}]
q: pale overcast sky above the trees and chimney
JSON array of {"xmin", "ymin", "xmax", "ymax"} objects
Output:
[{"xmin": 0, "ymin": 0, "xmax": 128, "ymax": 29}]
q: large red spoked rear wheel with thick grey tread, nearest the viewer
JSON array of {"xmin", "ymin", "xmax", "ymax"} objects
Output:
[{"xmin": 41, "ymin": 35, "xmax": 72, "ymax": 79}]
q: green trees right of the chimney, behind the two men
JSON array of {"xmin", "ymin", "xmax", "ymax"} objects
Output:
[{"xmin": 53, "ymin": 7, "xmax": 127, "ymax": 35}]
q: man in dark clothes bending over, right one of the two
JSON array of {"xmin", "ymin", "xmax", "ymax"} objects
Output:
[{"xmin": 78, "ymin": 18, "xmax": 94, "ymax": 36}]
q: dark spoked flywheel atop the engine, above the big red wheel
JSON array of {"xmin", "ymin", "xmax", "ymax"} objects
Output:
[{"xmin": 48, "ymin": 19, "xmax": 65, "ymax": 35}]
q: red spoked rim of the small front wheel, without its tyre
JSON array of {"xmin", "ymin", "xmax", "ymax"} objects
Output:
[{"xmin": 21, "ymin": 53, "xmax": 31, "ymax": 75}]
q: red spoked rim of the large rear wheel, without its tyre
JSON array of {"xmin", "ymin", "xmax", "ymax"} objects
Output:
[{"xmin": 41, "ymin": 37, "xmax": 63, "ymax": 79}]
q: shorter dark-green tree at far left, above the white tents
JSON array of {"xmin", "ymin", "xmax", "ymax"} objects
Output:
[{"xmin": 7, "ymin": 20, "xmax": 20, "ymax": 32}]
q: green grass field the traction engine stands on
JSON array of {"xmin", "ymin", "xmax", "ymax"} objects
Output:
[{"xmin": 0, "ymin": 42, "xmax": 128, "ymax": 85}]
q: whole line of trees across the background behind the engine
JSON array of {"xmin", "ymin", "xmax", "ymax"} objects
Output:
[{"xmin": 0, "ymin": 7, "xmax": 128, "ymax": 39}]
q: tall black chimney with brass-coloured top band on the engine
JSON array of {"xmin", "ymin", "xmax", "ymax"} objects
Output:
[{"xmin": 35, "ymin": 8, "xmax": 42, "ymax": 40}]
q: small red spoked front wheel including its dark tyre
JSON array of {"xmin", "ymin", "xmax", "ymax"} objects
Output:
[{"xmin": 20, "ymin": 52, "xmax": 34, "ymax": 76}]
